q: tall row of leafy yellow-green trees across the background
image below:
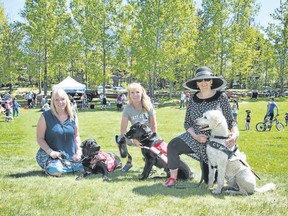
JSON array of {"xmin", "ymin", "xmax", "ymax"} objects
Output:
[{"xmin": 0, "ymin": 0, "xmax": 288, "ymax": 96}]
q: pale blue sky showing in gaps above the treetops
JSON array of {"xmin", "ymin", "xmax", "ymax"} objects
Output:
[{"xmin": 0, "ymin": 0, "xmax": 280, "ymax": 27}]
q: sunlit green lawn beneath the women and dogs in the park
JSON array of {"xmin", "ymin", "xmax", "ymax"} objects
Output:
[{"xmin": 0, "ymin": 100, "xmax": 288, "ymax": 215}]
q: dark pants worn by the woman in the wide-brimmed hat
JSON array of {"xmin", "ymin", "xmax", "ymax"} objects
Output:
[{"xmin": 167, "ymin": 137, "xmax": 209, "ymax": 184}]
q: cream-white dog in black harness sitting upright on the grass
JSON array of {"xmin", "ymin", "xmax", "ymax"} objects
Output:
[{"xmin": 197, "ymin": 110, "xmax": 275, "ymax": 195}]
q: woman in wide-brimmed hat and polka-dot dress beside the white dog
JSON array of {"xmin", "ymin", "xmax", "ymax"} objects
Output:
[{"xmin": 163, "ymin": 66, "xmax": 239, "ymax": 187}]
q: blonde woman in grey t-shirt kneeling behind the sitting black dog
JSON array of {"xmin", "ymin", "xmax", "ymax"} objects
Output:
[{"xmin": 120, "ymin": 83, "xmax": 157, "ymax": 172}]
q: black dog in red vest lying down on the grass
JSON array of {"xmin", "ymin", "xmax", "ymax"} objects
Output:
[{"xmin": 77, "ymin": 139, "xmax": 122, "ymax": 180}]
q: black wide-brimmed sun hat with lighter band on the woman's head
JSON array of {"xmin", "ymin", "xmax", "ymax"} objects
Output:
[{"xmin": 183, "ymin": 66, "xmax": 227, "ymax": 90}]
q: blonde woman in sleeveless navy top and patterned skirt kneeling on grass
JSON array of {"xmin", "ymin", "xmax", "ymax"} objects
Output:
[{"xmin": 36, "ymin": 89, "xmax": 83, "ymax": 176}]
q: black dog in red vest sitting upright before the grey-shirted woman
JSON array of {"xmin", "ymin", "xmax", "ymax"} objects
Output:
[{"xmin": 125, "ymin": 123, "xmax": 194, "ymax": 180}]
